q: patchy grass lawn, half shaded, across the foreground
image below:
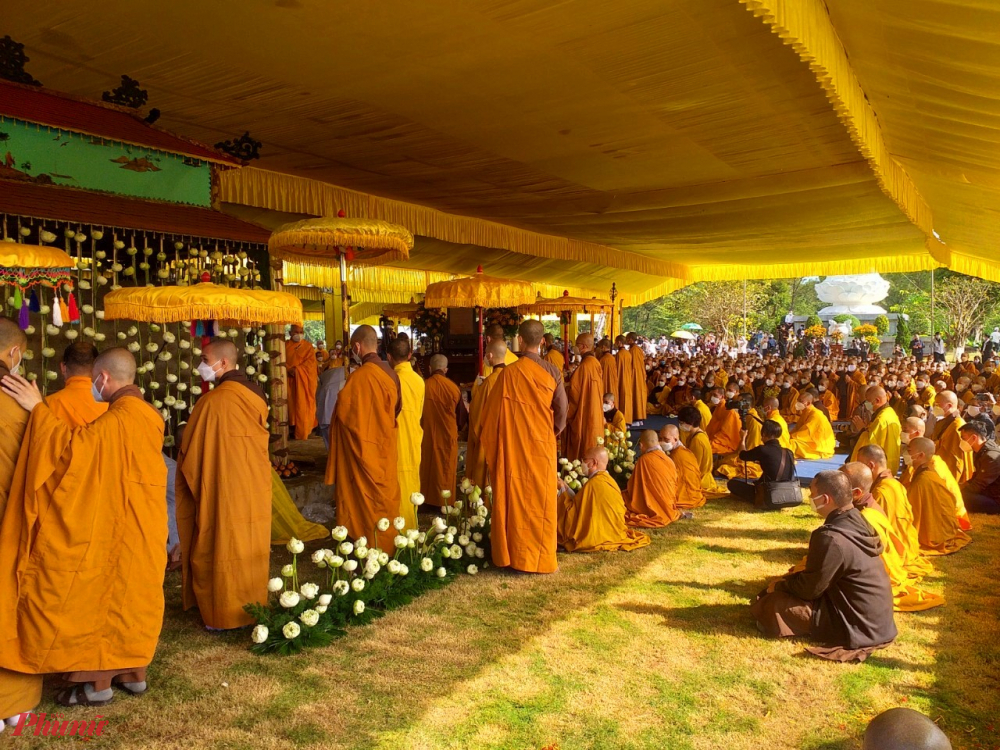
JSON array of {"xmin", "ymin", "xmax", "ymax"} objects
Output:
[{"xmin": 15, "ymin": 500, "xmax": 1000, "ymax": 750}]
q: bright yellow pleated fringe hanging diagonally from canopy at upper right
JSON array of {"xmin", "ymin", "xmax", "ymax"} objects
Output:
[{"xmin": 739, "ymin": 0, "xmax": 934, "ymax": 238}]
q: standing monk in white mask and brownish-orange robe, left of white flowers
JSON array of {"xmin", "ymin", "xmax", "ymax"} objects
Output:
[{"xmin": 175, "ymin": 339, "xmax": 271, "ymax": 630}]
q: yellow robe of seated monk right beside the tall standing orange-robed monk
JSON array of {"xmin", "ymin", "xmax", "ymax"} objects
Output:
[{"xmin": 558, "ymin": 471, "xmax": 649, "ymax": 552}]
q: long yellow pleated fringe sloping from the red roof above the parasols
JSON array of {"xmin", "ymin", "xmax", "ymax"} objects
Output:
[{"xmin": 219, "ymin": 167, "xmax": 686, "ymax": 280}]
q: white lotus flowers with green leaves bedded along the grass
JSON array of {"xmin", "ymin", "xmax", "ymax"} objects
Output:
[{"xmin": 244, "ymin": 479, "xmax": 492, "ymax": 656}]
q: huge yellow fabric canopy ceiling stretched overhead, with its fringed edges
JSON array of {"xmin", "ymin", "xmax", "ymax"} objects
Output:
[{"xmin": 4, "ymin": 0, "xmax": 1000, "ymax": 296}]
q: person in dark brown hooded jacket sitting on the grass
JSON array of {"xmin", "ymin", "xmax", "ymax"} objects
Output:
[{"xmin": 750, "ymin": 471, "xmax": 896, "ymax": 661}]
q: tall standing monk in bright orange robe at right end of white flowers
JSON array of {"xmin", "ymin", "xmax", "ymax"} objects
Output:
[{"xmin": 479, "ymin": 320, "xmax": 567, "ymax": 573}]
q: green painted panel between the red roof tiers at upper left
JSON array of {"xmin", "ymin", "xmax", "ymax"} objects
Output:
[{"xmin": 0, "ymin": 117, "xmax": 212, "ymax": 207}]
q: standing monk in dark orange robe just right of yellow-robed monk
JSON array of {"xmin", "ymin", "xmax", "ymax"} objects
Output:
[{"xmin": 420, "ymin": 354, "xmax": 465, "ymax": 506}]
